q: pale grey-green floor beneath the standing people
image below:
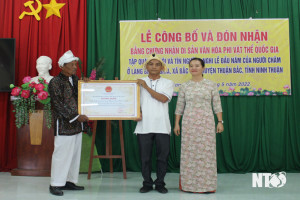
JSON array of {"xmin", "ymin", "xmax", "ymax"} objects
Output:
[{"xmin": 0, "ymin": 172, "xmax": 300, "ymax": 200}]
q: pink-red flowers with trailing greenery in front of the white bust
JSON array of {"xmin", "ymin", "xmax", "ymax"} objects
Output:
[{"xmin": 10, "ymin": 76, "xmax": 52, "ymax": 128}]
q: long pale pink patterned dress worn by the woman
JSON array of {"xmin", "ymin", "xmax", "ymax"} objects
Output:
[{"xmin": 175, "ymin": 79, "xmax": 222, "ymax": 192}]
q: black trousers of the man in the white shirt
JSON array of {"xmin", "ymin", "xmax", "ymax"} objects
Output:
[{"xmin": 137, "ymin": 133, "xmax": 170, "ymax": 187}]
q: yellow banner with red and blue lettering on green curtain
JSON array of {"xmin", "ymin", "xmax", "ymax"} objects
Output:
[{"xmin": 120, "ymin": 19, "xmax": 291, "ymax": 96}]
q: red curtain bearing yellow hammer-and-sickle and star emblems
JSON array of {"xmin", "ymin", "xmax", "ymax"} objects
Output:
[{"xmin": 0, "ymin": 0, "xmax": 87, "ymax": 171}]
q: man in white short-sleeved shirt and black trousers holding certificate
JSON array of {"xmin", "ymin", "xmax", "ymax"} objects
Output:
[{"xmin": 134, "ymin": 54, "xmax": 174, "ymax": 193}]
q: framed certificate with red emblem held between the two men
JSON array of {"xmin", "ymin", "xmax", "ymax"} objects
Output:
[{"xmin": 78, "ymin": 80, "xmax": 140, "ymax": 120}]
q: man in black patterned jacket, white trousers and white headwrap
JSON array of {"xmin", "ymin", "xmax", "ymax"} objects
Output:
[{"xmin": 49, "ymin": 50, "xmax": 89, "ymax": 196}]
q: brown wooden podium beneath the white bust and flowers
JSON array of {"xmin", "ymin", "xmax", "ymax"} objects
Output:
[{"xmin": 11, "ymin": 102, "xmax": 54, "ymax": 176}]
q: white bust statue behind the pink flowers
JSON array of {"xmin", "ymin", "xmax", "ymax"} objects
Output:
[{"xmin": 30, "ymin": 56, "xmax": 53, "ymax": 83}]
